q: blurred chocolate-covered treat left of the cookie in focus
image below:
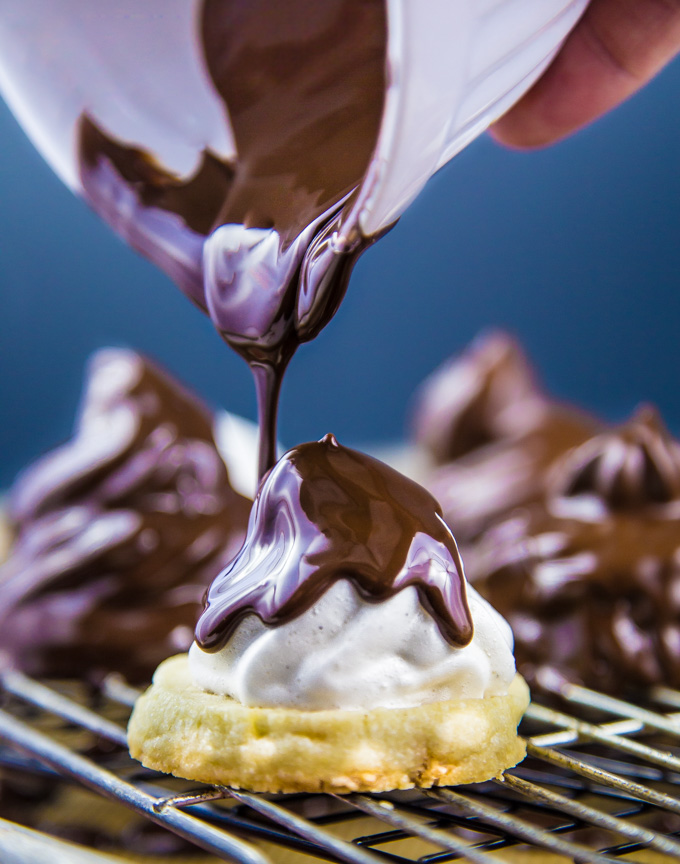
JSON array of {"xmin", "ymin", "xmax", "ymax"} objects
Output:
[{"xmin": 0, "ymin": 349, "xmax": 250, "ymax": 682}]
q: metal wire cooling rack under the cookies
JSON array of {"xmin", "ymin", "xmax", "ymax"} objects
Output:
[{"xmin": 0, "ymin": 669, "xmax": 680, "ymax": 864}]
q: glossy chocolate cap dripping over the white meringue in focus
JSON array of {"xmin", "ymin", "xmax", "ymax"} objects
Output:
[{"xmin": 196, "ymin": 435, "xmax": 472, "ymax": 651}]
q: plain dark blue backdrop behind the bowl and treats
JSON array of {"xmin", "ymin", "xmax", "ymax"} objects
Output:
[{"xmin": 0, "ymin": 62, "xmax": 680, "ymax": 488}]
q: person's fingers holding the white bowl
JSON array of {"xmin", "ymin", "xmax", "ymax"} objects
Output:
[{"xmin": 491, "ymin": 0, "xmax": 680, "ymax": 148}]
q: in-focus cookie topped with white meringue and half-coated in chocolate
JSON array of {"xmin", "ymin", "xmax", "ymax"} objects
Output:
[{"xmin": 128, "ymin": 435, "xmax": 528, "ymax": 792}]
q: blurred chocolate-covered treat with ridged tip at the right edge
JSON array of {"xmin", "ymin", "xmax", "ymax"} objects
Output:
[{"xmin": 467, "ymin": 409, "xmax": 680, "ymax": 693}]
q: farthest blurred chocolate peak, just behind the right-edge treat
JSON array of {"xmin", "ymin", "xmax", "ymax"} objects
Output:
[{"xmin": 414, "ymin": 331, "xmax": 601, "ymax": 543}]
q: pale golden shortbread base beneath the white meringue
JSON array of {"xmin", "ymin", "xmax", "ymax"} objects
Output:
[{"xmin": 128, "ymin": 655, "xmax": 529, "ymax": 793}]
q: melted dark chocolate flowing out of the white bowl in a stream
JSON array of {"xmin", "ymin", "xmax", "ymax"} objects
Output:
[{"xmin": 79, "ymin": 0, "xmax": 387, "ymax": 476}]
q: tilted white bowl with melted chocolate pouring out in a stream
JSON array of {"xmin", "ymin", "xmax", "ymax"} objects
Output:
[{"xmin": 0, "ymin": 0, "xmax": 587, "ymax": 473}]
